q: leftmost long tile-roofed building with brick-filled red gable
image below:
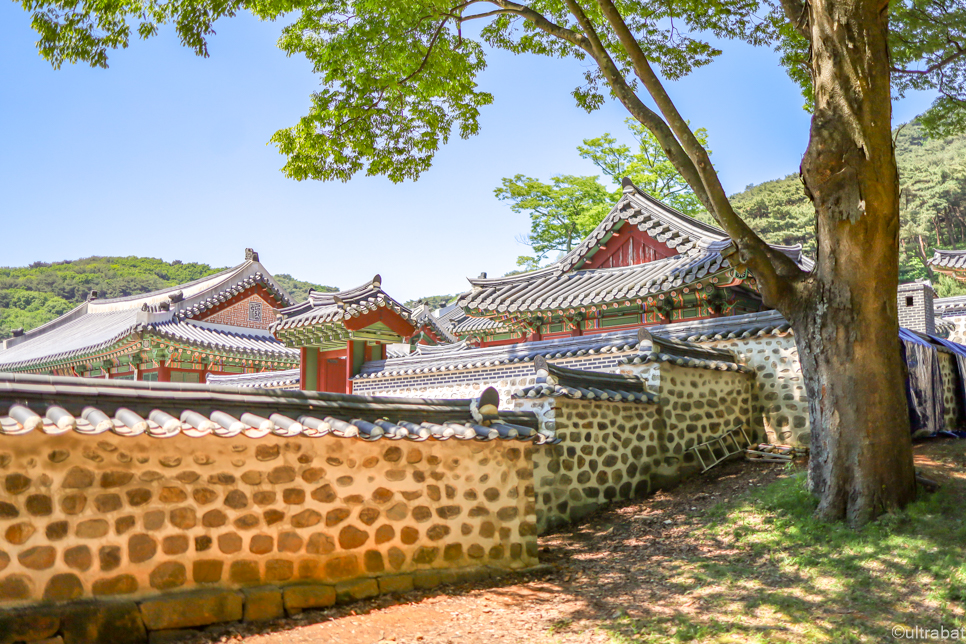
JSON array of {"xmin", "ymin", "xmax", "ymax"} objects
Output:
[{"xmin": 0, "ymin": 249, "xmax": 299, "ymax": 383}]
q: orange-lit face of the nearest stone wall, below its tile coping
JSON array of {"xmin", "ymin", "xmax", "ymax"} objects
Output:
[{"xmin": 0, "ymin": 431, "xmax": 539, "ymax": 612}]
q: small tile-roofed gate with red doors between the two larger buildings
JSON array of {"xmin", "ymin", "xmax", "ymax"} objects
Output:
[{"xmin": 270, "ymin": 275, "xmax": 418, "ymax": 393}]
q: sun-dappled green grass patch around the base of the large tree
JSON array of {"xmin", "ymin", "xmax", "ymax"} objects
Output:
[{"xmin": 607, "ymin": 474, "xmax": 966, "ymax": 643}]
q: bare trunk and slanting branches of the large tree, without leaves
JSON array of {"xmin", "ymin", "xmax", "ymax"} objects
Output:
[{"xmin": 499, "ymin": 0, "xmax": 915, "ymax": 525}]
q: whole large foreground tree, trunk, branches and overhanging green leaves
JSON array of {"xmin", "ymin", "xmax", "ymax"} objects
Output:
[{"xmin": 22, "ymin": 0, "xmax": 966, "ymax": 524}]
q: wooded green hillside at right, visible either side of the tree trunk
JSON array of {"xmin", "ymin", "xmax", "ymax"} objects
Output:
[{"xmin": 731, "ymin": 122, "xmax": 966, "ymax": 296}]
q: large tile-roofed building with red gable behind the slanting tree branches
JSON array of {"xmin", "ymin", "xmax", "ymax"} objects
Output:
[{"xmin": 451, "ymin": 179, "xmax": 812, "ymax": 346}]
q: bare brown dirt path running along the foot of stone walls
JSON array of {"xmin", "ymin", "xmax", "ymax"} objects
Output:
[{"xmin": 183, "ymin": 440, "xmax": 966, "ymax": 644}]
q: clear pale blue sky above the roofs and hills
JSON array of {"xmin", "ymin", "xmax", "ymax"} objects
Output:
[{"xmin": 0, "ymin": 2, "xmax": 930, "ymax": 300}]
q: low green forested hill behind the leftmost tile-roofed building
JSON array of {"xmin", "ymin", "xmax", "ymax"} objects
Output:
[{"xmin": 0, "ymin": 257, "xmax": 337, "ymax": 339}]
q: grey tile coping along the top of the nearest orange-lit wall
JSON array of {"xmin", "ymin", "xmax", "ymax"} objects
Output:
[{"xmin": 0, "ymin": 373, "xmax": 555, "ymax": 444}]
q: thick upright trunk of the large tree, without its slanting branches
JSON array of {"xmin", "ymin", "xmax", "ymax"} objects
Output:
[{"xmin": 792, "ymin": 0, "xmax": 915, "ymax": 525}]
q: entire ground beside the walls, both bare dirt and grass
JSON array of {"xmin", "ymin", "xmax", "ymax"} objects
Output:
[{"xmin": 185, "ymin": 440, "xmax": 966, "ymax": 644}]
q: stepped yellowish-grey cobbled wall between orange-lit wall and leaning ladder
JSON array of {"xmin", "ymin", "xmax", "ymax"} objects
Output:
[{"xmin": 517, "ymin": 363, "xmax": 751, "ymax": 533}]
